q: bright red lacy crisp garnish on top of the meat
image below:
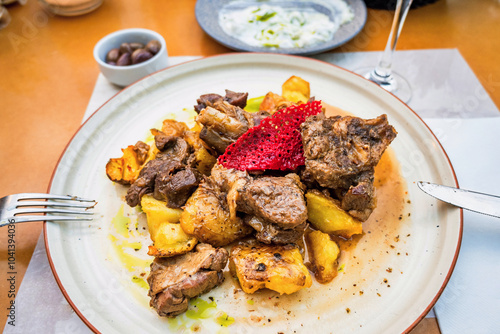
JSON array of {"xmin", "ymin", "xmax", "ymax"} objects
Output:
[{"xmin": 219, "ymin": 101, "xmax": 321, "ymax": 171}]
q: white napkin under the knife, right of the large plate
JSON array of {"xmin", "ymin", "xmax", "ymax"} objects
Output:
[{"xmin": 426, "ymin": 117, "xmax": 500, "ymax": 334}]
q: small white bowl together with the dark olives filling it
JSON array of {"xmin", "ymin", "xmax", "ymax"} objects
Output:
[{"xmin": 94, "ymin": 28, "xmax": 168, "ymax": 86}]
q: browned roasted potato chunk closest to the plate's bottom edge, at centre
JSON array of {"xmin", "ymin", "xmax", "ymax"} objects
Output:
[{"xmin": 229, "ymin": 242, "xmax": 312, "ymax": 294}]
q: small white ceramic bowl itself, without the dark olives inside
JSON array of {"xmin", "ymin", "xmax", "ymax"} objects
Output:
[{"xmin": 94, "ymin": 28, "xmax": 168, "ymax": 87}]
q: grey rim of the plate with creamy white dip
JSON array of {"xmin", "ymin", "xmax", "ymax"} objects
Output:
[{"xmin": 195, "ymin": 0, "xmax": 368, "ymax": 56}]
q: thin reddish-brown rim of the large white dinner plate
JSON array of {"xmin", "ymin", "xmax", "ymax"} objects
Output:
[{"xmin": 43, "ymin": 52, "xmax": 464, "ymax": 333}]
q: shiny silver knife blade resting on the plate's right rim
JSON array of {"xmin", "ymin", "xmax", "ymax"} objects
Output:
[{"xmin": 417, "ymin": 181, "xmax": 500, "ymax": 218}]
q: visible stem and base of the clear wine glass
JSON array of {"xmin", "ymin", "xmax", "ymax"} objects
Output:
[{"xmin": 354, "ymin": 0, "xmax": 413, "ymax": 102}]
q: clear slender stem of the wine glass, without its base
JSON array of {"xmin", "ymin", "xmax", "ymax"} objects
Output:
[{"xmin": 373, "ymin": 0, "xmax": 413, "ymax": 82}]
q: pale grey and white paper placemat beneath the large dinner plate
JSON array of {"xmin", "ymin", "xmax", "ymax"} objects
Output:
[{"xmin": 4, "ymin": 49, "xmax": 500, "ymax": 334}]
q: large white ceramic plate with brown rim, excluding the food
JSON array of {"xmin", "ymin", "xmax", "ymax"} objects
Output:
[{"xmin": 44, "ymin": 54, "xmax": 462, "ymax": 333}]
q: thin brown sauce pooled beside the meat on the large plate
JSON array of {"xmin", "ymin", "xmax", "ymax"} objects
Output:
[{"xmin": 221, "ymin": 103, "xmax": 410, "ymax": 329}]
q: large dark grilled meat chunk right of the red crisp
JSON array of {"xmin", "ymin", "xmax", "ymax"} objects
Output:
[{"xmin": 301, "ymin": 114, "xmax": 397, "ymax": 189}]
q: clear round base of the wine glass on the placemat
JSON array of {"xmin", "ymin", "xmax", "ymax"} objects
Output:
[{"xmin": 353, "ymin": 66, "xmax": 412, "ymax": 103}]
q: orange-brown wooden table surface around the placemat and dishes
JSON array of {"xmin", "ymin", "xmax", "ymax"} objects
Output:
[{"xmin": 0, "ymin": 0, "xmax": 500, "ymax": 334}]
